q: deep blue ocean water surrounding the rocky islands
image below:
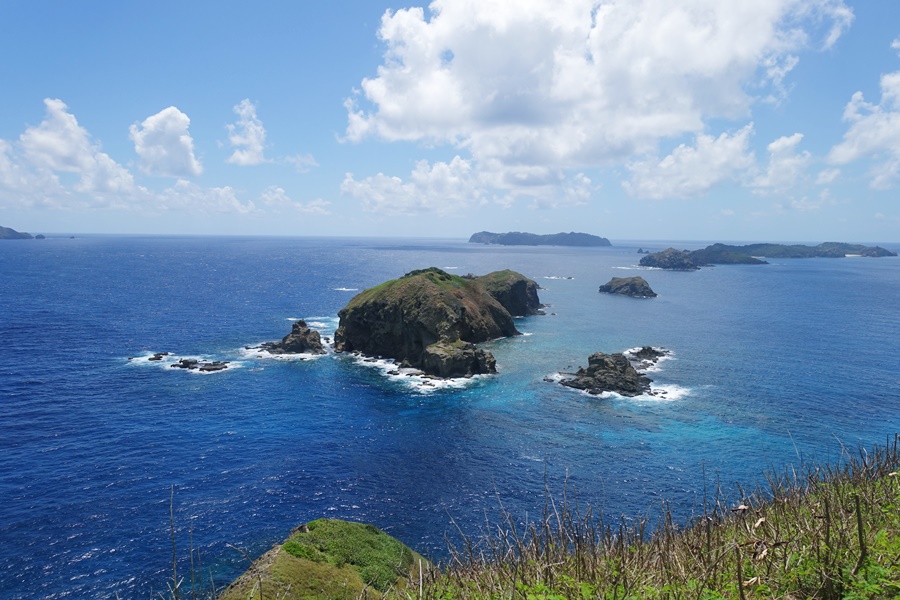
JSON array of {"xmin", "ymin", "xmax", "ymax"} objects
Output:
[{"xmin": 0, "ymin": 236, "xmax": 900, "ymax": 599}]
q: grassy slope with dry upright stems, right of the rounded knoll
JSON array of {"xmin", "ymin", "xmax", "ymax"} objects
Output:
[{"xmin": 423, "ymin": 440, "xmax": 900, "ymax": 600}]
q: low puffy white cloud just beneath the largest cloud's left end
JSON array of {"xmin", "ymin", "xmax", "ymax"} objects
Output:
[{"xmin": 341, "ymin": 156, "xmax": 481, "ymax": 215}]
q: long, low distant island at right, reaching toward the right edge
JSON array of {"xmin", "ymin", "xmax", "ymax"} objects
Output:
[{"xmin": 640, "ymin": 242, "xmax": 897, "ymax": 271}]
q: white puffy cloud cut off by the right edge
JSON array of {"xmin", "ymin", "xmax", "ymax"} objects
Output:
[{"xmin": 828, "ymin": 66, "xmax": 900, "ymax": 189}]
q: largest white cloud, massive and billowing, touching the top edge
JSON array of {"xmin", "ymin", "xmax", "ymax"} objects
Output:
[{"xmin": 346, "ymin": 0, "xmax": 852, "ymax": 175}]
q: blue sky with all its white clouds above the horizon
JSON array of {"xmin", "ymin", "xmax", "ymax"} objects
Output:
[{"xmin": 0, "ymin": 0, "xmax": 900, "ymax": 243}]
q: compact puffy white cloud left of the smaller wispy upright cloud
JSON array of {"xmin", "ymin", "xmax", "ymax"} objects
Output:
[{"xmin": 129, "ymin": 106, "xmax": 203, "ymax": 177}]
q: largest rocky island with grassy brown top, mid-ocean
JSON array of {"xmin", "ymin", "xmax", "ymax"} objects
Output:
[{"xmin": 334, "ymin": 267, "xmax": 542, "ymax": 378}]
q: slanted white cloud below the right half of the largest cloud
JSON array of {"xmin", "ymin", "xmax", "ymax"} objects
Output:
[{"xmin": 622, "ymin": 123, "xmax": 754, "ymax": 200}]
